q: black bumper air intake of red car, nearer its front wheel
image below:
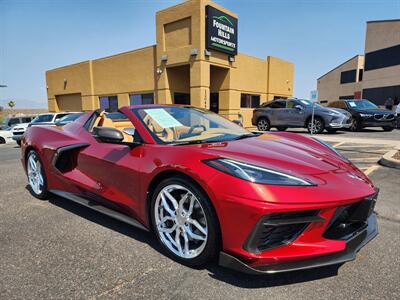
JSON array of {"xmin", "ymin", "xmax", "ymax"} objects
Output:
[{"xmin": 244, "ymin": 210, "xmax": 324, "ymax": 253}]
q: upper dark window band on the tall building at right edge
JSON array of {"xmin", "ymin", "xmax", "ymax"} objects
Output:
[{"xmin": 364, "ymin": 45, "xmax": 400, "ymax": 71}]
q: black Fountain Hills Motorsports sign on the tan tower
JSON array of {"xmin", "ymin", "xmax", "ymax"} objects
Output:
[{"xmin": 206, "ymin": 5, "xmax": 237, "ymax": 55}]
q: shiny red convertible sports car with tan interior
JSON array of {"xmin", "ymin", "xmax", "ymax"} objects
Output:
[{"xmin": 22, "ymin": 105, "xmax": 378, "ymax": 274}]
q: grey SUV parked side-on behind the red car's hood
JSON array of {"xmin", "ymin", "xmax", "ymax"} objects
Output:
[{"xmin": 252, "ymin": 99, "xmax": 351, "ymax": 133}]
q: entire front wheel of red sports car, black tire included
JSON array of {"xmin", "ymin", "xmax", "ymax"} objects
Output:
[{"xmin": 150, "ymin": 176, "xmax": 221, "ymax": 267}]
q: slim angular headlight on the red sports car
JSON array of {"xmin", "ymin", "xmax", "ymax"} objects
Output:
[{"xmin": 203, "ymin": 158, "xmax": 315, "ymax": 186}]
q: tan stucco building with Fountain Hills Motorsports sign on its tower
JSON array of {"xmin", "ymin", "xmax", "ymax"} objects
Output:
[{"xmin": 46, "ymin": 0, "xmax": 294, "ymax": 126}]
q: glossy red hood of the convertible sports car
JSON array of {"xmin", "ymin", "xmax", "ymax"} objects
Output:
[{"xmin": 201, "ymin": 134, "xmax": 352, "ymax": 175}]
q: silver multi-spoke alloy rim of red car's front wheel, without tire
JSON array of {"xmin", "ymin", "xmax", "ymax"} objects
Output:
[{"xmin": 154, "ymin": 184, "xmax": 208, "ymax": 259}]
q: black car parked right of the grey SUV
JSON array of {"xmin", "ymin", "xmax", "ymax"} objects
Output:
[{"xmin": 328, "ymin": 99, "xmax": 396, "ymax": 131}]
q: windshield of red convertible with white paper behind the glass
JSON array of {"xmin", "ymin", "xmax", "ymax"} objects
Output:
[{"xmin": 132, "ymin": 106, "xmax": 256, "ymax": 144}]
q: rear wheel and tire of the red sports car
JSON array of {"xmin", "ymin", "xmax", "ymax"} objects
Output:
[{"xmin": 26, "ymin": 150, "xmax": 49, "ymax": 200}]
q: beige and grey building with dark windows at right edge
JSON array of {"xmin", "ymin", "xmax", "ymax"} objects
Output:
[{"xmin": 317, "ymin": 19, "xmax": 400, "ymax": 105}]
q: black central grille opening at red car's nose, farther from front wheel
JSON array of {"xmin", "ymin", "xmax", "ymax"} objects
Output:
[{"xmin": 322, "ymin": 195, "xmax": 376, "ymax": 240}]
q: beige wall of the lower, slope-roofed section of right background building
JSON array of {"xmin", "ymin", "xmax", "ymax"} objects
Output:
[{"xmin": 317, "ymin": 55, "xmax": 364, "ymax": 101}]
